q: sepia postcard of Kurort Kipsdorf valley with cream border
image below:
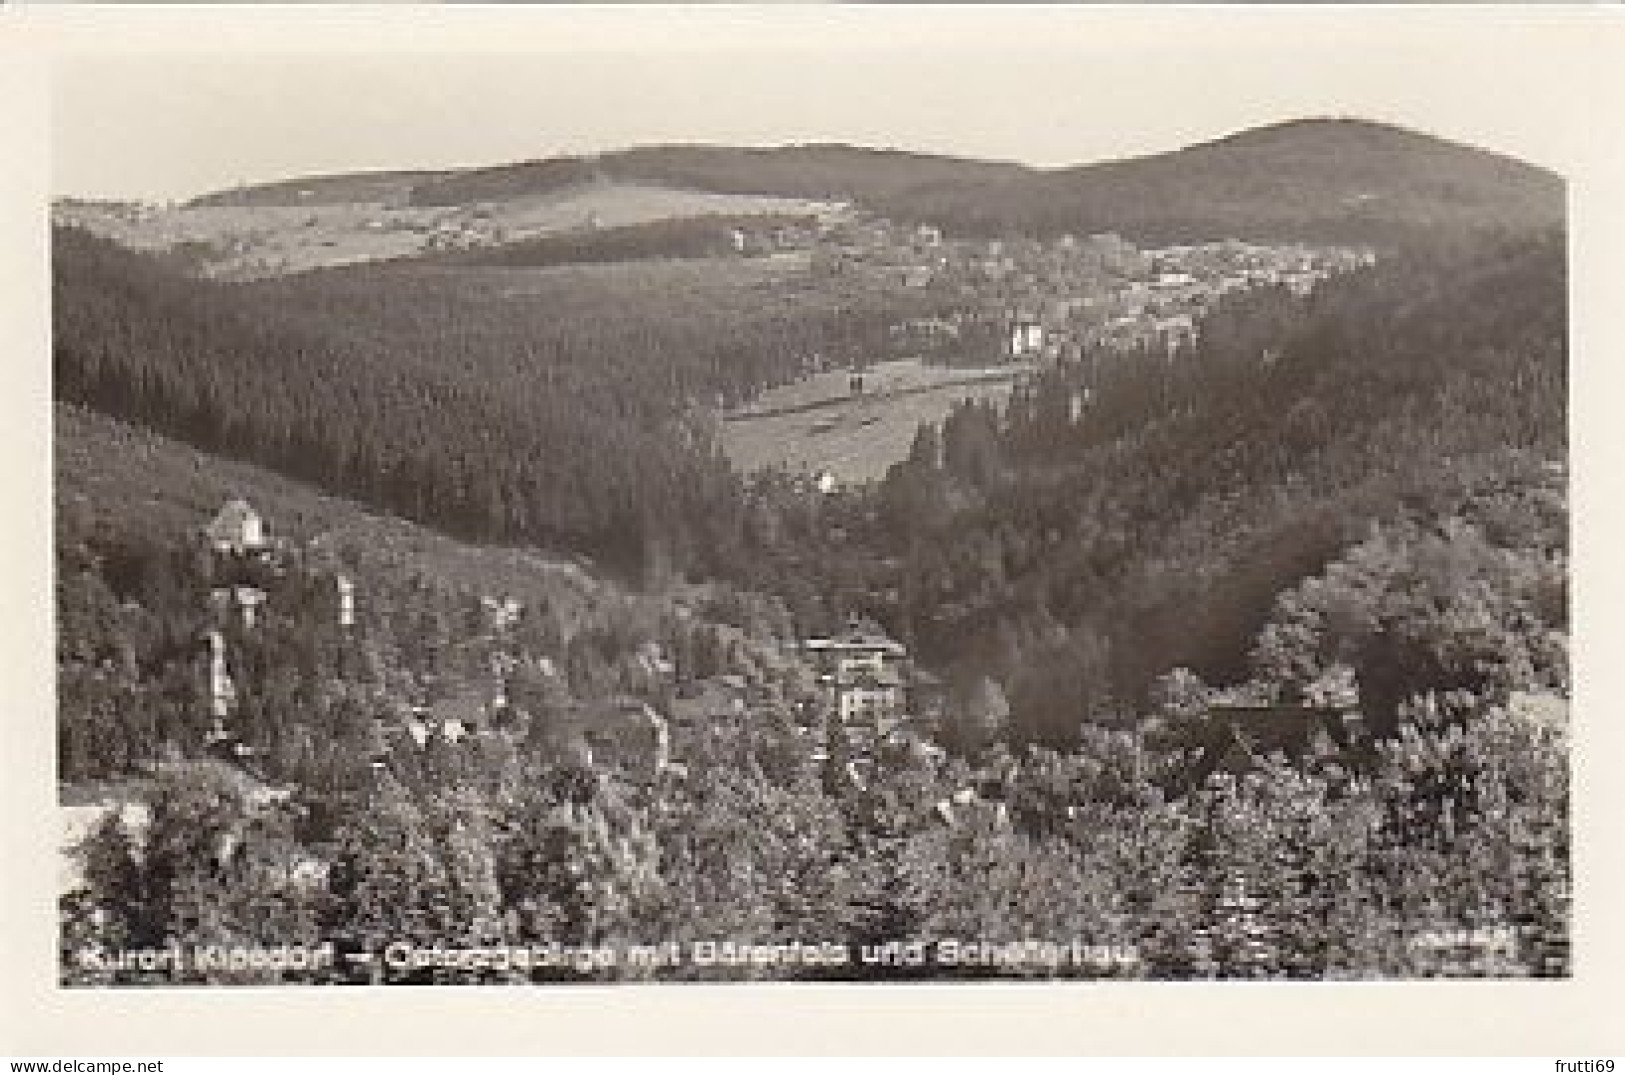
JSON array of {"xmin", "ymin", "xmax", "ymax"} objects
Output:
[{"xmin": 8, "ymin": 6, "xmax": 1619, "ymax": 1047}]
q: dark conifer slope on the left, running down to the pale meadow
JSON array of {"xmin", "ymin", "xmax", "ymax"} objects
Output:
[{"xmin": 54, "ymin": 229, "xmax": 942, "ymax": 573}]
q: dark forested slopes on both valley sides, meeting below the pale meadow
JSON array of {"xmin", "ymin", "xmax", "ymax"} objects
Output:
[{"xmin": 57, "ymin": 220, "xmax": 1567, "ymax": 753}]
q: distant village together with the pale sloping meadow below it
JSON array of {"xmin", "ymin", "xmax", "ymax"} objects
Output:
[{"xmin": 720, "ymin": 214, "xmax": 1376, "ymax": 492}]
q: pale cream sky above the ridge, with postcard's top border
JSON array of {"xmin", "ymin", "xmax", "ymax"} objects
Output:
[{"xmin": 52, "ymin": 6, "xmax": 1601, "ymax": 200}]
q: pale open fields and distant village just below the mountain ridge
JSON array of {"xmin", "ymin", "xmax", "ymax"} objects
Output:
[{"xmin": 52, "ymin": 185, "xmax": 1376, "ymax": 365}]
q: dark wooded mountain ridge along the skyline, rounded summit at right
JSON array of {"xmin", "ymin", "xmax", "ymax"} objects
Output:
[{"xmin": 181, "ymin": 117, "xmax": 1563, "ymax": 239}]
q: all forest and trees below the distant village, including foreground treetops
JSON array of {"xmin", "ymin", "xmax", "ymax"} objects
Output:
[{"xmin": 54, "ymin": 120, "xmax": 1570, "ymax": 986}]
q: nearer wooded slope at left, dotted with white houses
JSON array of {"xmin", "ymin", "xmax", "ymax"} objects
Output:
[{"xmin": 55, "ymin": 406, "xmax": 806, "ymax": 791}]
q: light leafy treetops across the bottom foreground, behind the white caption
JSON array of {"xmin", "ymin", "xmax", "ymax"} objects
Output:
[{"xmin": 63, "ymin": 685, "xmax": 1568, "ymax": 984}]
